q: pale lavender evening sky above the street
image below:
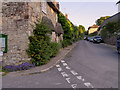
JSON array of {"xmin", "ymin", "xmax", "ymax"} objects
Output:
[{"xmin": 57, "ymin": 0, "xmax": 118, "ymax": 30}]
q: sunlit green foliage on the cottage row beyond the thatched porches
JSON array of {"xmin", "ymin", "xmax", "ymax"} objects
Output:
[{"xmin": 58, "ymin": 13, "xmax": 85, "ymax": 48}]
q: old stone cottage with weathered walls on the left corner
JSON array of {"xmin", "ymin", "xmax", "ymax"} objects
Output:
[{"xmin": 1, "ymin": 2, "xmax": 63, "ymax": 66}]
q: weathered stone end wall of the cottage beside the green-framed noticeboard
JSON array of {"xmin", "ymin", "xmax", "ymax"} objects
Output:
[{"xmin": 2, "ymin": 2, "xmax": 29, "ymax": 65}]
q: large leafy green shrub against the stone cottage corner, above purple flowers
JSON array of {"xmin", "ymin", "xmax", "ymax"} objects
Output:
[{"xmin": 27, "ymin": 21, "xmax": 59, "ymax": 66}]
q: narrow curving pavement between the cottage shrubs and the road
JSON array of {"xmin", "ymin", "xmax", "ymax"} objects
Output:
[{"xmin": 0, "ymin": 42, "xmax": 78, "ymax": 75}]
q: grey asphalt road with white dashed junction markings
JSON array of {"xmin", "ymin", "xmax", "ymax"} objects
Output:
[{"xmin": 3, "ymin": 40, "xmax": 119, "ymax": 88}]
